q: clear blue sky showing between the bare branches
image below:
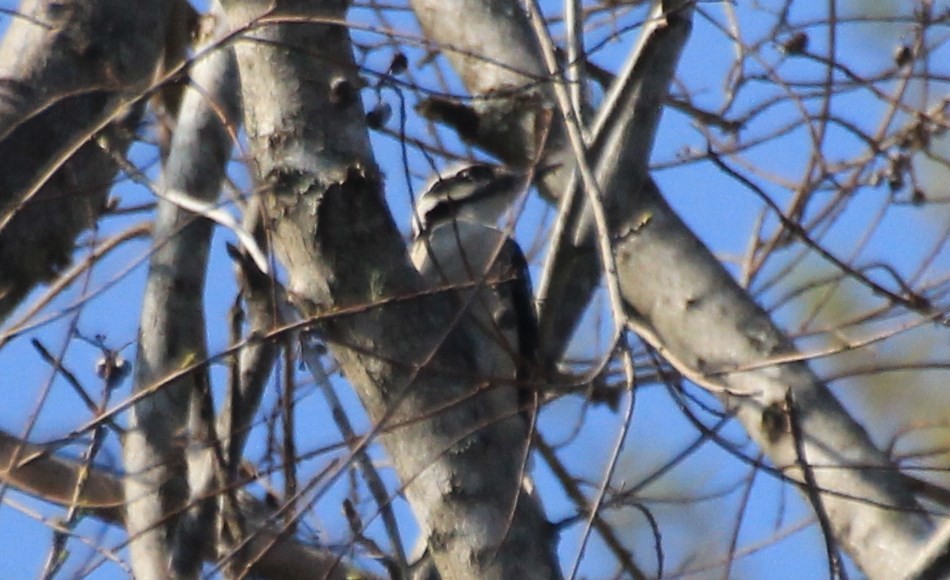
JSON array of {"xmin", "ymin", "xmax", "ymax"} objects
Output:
[{"xmin": 0, "ymin": 2, "xmax": 950, "ymax": 579}]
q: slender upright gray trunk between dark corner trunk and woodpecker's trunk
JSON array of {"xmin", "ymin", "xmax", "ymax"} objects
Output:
[{"xmin": 123, "ymin": 12, "xmax": 240, "ymax": 579}]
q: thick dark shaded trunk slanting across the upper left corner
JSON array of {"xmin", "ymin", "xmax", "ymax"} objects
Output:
[{"xmin": 0, "ymin": 0, "xmax": 170, "ymax": 319}]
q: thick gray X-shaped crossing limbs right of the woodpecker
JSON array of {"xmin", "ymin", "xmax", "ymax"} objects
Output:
[{"xmin": 412, "ymin": 0, "xmax": 933, "ymax": 578}]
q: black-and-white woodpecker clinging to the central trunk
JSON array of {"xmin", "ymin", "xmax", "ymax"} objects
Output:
[{"xmin": 410, "ymin": 163, "xmax": 538, "ymax": 426}]
